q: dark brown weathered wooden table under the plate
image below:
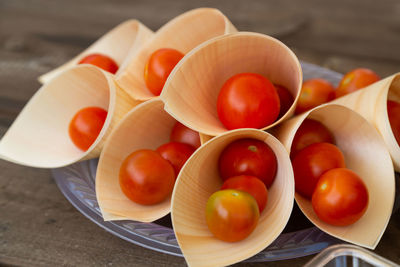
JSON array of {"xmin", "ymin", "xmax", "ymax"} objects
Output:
[{"xmin": 0, "ymin": 0, "xmax": 400, "ymax": 266}]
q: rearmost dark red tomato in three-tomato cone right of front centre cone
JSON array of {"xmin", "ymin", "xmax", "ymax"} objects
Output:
[{"xmin": 290, "ymin": 119, "xmax": 335, "ymax": 158}]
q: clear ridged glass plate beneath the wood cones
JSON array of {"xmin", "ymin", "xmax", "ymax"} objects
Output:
[{"xmin": 52, "ymin": 62, "xmax": 394, "ymax": 262}]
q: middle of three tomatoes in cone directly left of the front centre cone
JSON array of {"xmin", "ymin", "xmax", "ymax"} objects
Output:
[{"xmin": 157, "ymin": 142, "xmax": 195, "ymax": 176}]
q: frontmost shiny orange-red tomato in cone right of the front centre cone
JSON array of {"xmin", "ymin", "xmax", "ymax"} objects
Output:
[{"xmin": 312, "ymin": 168, "xmax": 368, "ymax": 226}]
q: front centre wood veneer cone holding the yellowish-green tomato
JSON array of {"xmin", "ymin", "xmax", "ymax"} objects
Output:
[{"xmin": 171, "ymin": 129, "xmax": 294, "ymax": 266}]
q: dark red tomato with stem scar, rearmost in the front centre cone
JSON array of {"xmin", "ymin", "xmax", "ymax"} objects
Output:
[{"xmin": 218, "ymin": 138, "xmax": 278, "ymax": 188}]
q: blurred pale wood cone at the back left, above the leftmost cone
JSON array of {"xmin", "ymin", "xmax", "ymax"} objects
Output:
[{"xmin": 38, "ymin": 20, "xmax": 153, "ymax": 83}]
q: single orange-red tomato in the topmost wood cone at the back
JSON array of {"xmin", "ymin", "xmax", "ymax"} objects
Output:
[{"xmin": 144, "ymin": 48, "xmax": 184, "ymax": 95}]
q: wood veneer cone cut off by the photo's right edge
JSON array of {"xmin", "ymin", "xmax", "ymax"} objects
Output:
[{"xmin": 332, "ymin": 73, "xmax": 400, "ymax": 171}]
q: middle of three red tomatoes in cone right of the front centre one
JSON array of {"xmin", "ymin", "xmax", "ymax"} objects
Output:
[{"xmin": 292, "ymin": 143, "xmax": 346, "ymax": 199}]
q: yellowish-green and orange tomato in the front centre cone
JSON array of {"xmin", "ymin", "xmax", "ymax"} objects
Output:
[{"xmin": 206, "ymin": 189, "xmax": 260, "ymax": 242}]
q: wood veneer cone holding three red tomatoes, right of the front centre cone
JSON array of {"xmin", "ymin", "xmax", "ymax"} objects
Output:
[{"xmin": 273, "ymin": 104, "xmax": 395, "ymax": 249}]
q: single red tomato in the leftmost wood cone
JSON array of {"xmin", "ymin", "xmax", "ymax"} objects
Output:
[{"xmin": 68, "ymin": 107, "xmax": 107, "ymax": 151}]
